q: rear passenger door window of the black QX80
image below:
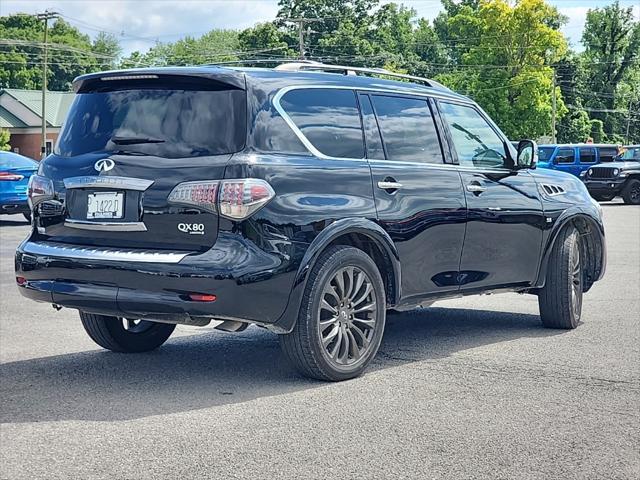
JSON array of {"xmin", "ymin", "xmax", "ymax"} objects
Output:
[{"xmin": 371, "ymin": 95, "xmax": 442, "ymax": 163}]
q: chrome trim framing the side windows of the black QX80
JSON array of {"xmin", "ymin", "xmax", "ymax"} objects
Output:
[{"xmin": 272, "ymin": 84, "xmax": 473, "ymax": 167}]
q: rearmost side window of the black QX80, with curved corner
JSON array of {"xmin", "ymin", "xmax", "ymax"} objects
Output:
[{"xmin": 280, "ymin": 88, "xmax": 364, "ymax": 158}]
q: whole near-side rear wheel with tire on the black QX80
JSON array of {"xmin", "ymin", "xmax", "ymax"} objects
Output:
[{"xmin": 280, "ymin": 246, "xmax": 386, "ymax": 381}]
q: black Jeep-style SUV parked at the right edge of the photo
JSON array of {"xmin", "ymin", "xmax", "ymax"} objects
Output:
[{"xmin": 581, "ymin": 145, "xmax": 640, "ymax": 205}]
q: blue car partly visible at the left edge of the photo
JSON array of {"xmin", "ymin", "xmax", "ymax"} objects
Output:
[{"xmin": 0, "ymin": 152, "xmax": 38, "ymax": 221}]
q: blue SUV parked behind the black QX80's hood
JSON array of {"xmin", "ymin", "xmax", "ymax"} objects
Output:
[{"xmin": 538, "ymin": 143, "xmax": 619, "ymax": 177}]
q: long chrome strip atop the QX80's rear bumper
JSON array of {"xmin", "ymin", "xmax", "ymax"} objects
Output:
[{"xmin": 22, "ymin": 242, "xmax": 189, "ymax": 263}]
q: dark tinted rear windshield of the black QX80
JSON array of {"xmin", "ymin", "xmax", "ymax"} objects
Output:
[{"xmin": 55, "ymin": 89, "xmax": 246, "ymax": 158}]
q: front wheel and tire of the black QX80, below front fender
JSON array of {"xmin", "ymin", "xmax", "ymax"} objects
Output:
[{"xmin": 538, "ymin": 226, "xmax": 584, "ymax": 329}]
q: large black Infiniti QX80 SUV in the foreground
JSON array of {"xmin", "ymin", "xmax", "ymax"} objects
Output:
[{"xmin": 16, "ymin": 63, "xmax": 606, "ymax": 380}]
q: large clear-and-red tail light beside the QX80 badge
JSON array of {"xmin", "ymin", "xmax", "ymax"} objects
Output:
[{"xmin": 168, "ymin": 178, "xmax": 275, "ymax": 220}]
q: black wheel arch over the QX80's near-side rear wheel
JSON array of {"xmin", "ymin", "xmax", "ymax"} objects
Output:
[{"xmin": 272, "ymin": 218, "xmax": 401, "ymax": 333}]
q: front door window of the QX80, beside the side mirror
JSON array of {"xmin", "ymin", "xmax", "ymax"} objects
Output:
[{"xmin": 440, "ymin": 103, "xmax": 508, "ymax": 168}]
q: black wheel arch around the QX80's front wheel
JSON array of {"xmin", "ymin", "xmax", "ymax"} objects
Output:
[{"xmin": 536, "ymin": 208, "xmax": 607, "ymax": 292}]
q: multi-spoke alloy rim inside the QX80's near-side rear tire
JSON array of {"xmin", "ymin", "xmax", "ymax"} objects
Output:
[{"xmin": 318, "ymin": 266, "xmax": 379, "ymax": 367}]
